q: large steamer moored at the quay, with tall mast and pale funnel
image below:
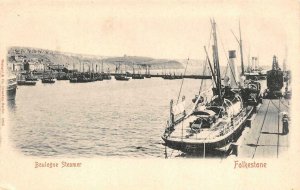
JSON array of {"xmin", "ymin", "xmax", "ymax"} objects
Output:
[{"xmin": 162, "ymin": 20, "xmax": 260, "ymax": 153}]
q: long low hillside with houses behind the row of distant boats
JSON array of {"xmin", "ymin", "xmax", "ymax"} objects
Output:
[{"xmin": 8, "ymin": 47, "xmax": 183, "ymax": 70}]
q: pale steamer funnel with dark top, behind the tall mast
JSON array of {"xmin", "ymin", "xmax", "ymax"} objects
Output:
[{"xmin": 227, "ymin": 50, "xmax": 239, "ymax": 88}]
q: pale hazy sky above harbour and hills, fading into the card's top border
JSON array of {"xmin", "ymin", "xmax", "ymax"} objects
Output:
[{"xmin": 0, "ymin": 1, "xmax": 299, "ymax": 65}]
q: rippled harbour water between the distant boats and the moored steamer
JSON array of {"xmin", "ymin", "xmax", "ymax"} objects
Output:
[{"xmin": 9, "ymin": 78, "xmax": 209, "ymax": 157}]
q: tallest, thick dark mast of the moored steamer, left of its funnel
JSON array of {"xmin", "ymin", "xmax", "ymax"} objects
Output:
[{"xmin": 211, "ymin": 19, "xmax": 222, "ymax": 102}]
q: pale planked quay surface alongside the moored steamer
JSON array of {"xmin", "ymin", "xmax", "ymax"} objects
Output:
[{"xmin": 237, "ymin": 99, "xmax": 289, "ymax": 158}]
